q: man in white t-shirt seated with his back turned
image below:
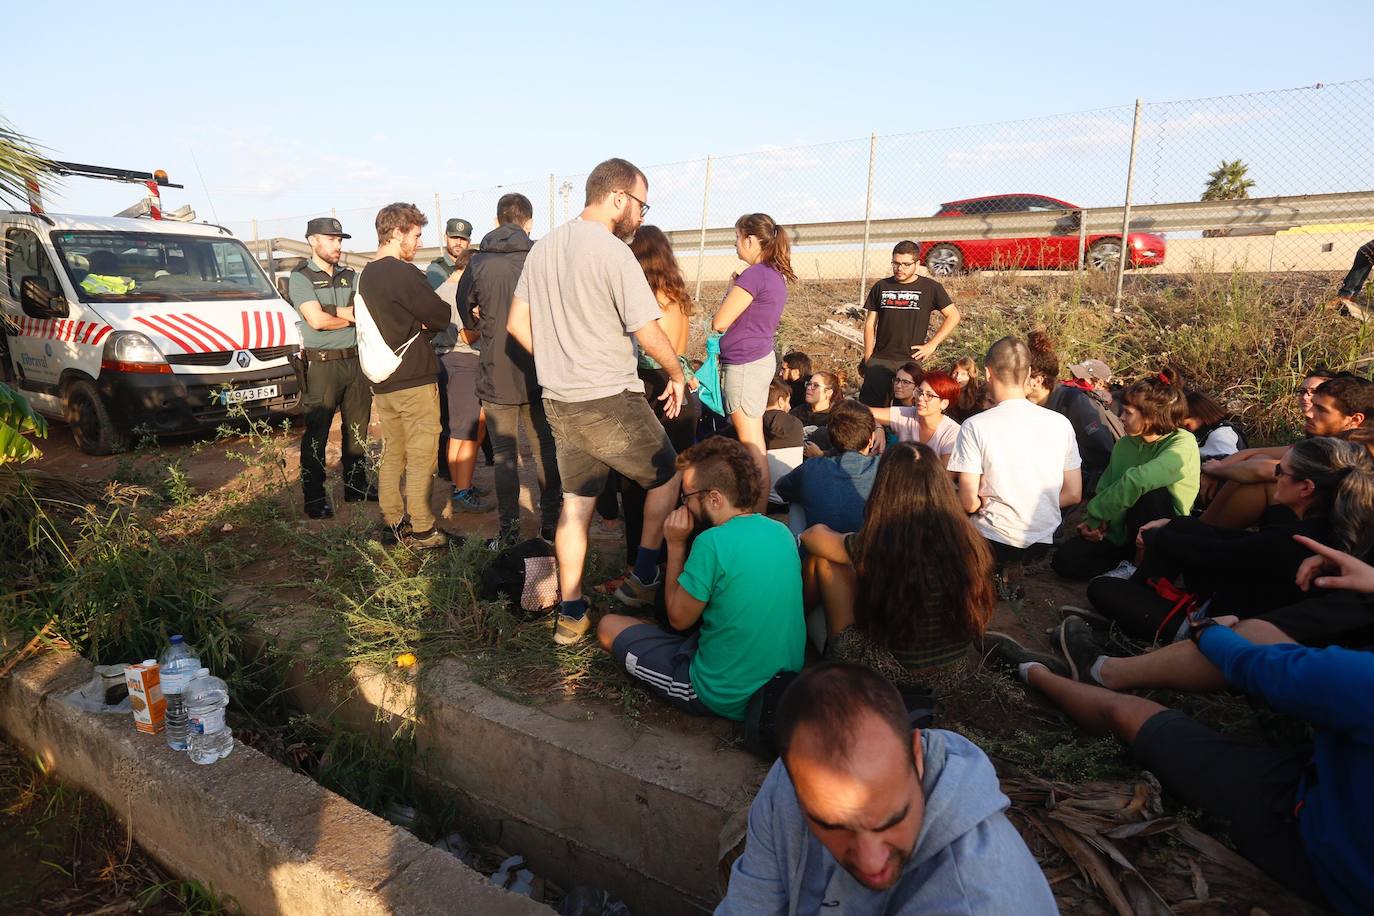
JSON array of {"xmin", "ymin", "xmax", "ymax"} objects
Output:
[{"xmin": 949, "ymin": 336, "xmax": 1083, "ymax": 566}]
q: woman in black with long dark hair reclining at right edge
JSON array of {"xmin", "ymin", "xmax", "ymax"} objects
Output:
[{"xmin": 1071, "ymin": 437, "xmax": 1374, "ymax": 641}]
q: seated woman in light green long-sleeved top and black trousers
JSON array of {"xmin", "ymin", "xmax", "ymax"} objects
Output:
[{"xmin": 1052, "ymin": 369, "xmax": 1202, "ymax": 580}]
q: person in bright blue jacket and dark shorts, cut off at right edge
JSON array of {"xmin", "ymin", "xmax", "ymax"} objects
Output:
[{"xmin": 1000, "ymin": 540, "xmax": 1374, "ymax": 913}]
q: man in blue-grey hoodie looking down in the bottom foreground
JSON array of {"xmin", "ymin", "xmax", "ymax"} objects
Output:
[{"xmin": 716, "ymin": 663, "xmax": 1058, "ymax": 916}]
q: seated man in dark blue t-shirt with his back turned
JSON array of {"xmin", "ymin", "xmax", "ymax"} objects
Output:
[{"xmin": 775, "ymin": 401, "xmax": 878, "ymax": 531}]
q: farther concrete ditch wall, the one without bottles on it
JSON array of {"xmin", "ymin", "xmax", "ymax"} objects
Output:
[{"xmin": 265, "ymin": 623, "xmax": 768, "ymax": 916}]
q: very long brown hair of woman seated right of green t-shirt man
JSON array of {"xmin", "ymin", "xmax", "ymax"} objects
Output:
[{"xmin": 853, "ymin": 442, "xmax": 996, "ymax": 648}]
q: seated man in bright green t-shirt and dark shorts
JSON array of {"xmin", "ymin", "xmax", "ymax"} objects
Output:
[{"xmin": 596, "ymin": 437, "xmax": 807, "ymax": 721}]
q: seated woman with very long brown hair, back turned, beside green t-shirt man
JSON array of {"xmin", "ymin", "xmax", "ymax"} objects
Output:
[{"xmin": 801, "ymin": 442, "xmax": 996, "ymax": 684}]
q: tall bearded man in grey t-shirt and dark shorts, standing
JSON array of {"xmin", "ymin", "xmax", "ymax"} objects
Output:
[{"xmin": 507, "ymin": 159, "xmax": 686, "ymax": 645}]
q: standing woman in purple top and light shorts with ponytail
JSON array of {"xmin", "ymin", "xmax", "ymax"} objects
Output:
[{"xmin": 712, "ymin": 213, "xmax": 797, "ymax": 512}]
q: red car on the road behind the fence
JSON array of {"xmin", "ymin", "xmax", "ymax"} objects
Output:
[{"xmin": 921, "ymin": 194, "xmax": 1164, "ymax": 276}]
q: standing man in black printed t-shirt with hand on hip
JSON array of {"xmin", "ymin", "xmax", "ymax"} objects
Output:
[{"xmin": 859, "ymin": 242, "xmax": 959, "ymax": 407}]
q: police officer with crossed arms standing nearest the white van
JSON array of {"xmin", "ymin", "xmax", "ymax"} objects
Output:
[{"xmin": 289, "ymin": 217, "xmax": 376, "ymax": 519}]
